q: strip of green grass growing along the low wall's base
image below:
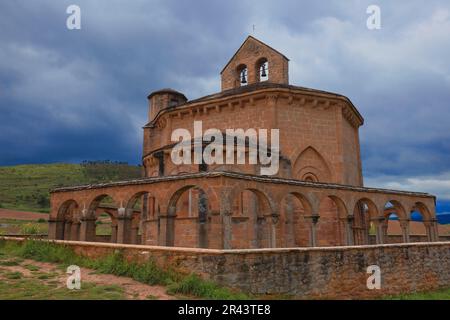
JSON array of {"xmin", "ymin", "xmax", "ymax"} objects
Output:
[{"xmin": 0, "ymin": 240, "xmax": 250, "ymax": 299}]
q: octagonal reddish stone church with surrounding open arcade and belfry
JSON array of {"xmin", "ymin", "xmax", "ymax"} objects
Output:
[{"xmin": 49, "ymin": 36, "xmax": 438, "ymax": 249}]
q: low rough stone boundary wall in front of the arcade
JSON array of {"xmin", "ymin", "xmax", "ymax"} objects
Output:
[{"xmin": 4, "ymin": 238, "xmax": 450, "ymax": 299}]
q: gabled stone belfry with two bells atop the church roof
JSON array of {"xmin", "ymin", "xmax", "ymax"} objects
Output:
[{"xmin": 220, "ymin": 36, "xmax": 289, "ymax": 91}]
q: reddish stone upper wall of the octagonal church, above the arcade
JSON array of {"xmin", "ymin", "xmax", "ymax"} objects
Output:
[{"xmin": 144, "ymin": 93, "xmax": 362, "ymax": 185}]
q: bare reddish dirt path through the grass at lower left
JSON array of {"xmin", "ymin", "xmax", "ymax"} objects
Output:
[{"xmin": 2, "ymin": 259, "xmax": 176, "ymax": 300}]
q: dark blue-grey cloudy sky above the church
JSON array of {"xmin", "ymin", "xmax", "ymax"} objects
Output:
[{"xmin": 0, "ymin": 0, "xmax": 450, "ymax": 211}]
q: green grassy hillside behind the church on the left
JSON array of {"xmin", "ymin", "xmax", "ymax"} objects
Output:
[{"xmin": 0, "ymin": 161, "xmax": 141, "ymax": 212}]
